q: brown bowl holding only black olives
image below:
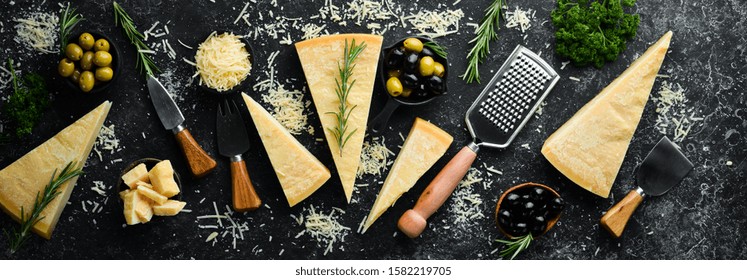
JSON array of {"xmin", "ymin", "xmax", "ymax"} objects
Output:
[{"xmin": 495, "ymin": 183, "xmax": 564, "ymax": 238}]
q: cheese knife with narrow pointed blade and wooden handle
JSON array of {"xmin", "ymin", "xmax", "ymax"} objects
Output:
[{"xmin": 148, "ymin": 75, "xmax": 216, "ymax": 178}]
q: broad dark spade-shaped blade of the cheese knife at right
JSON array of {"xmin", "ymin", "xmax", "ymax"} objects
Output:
[{"xmin": 636, "ymin": 136, "xmax": 693, "ymax": 196}]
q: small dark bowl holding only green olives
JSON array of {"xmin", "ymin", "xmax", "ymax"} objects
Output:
[{"xmin": 57, "ymin": 31, "xmax": 122, "ymax": 94}]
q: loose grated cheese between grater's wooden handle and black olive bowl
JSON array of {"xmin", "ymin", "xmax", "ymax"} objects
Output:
[{"xmin": 449, "ymin": 167, "xmax": 492, "ymax": 229}]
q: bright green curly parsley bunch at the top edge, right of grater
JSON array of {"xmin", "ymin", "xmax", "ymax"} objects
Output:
[{"xmin": 550, "ymin": 0, "xmax": 641, "ymax": 68}]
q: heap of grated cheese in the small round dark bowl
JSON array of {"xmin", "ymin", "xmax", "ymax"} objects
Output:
[{"xmin": 195, "ymin": 32, "xmax": 252, "ymax": 91}]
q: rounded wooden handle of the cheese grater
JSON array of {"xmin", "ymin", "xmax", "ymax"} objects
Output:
[{"xmin": 397, "ymin": 147, "xmax": 477, "ymax": 238}]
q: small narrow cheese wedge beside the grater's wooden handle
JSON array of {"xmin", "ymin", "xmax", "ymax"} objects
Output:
[{"xmin": 363, "ymin": 118, "xmax": 454, "ymax": 232}]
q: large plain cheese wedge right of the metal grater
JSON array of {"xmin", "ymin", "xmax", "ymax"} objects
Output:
[{"xmin": 542, "ymin": 31, "xmax": 672, "ymax": 197}]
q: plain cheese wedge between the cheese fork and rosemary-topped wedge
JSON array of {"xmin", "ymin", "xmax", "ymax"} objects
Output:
[{"xmin": 242, "ymin": 93, "xmax": 332, "ymax": 207}]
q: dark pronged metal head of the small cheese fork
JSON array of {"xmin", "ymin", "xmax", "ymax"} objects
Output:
[{"xmin": 216, "ymin": 100, "xmax": 250, "ymax": 157}]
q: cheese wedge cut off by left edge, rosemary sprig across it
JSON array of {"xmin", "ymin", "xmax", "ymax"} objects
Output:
[{"xmin": 0, "ymin": 101, "xmax": 111, "ymax": 239}]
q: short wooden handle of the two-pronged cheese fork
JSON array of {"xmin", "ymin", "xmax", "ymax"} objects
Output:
[{"xmin": 231, "ymin": 160, "xmax": 262, "ymax": 212}]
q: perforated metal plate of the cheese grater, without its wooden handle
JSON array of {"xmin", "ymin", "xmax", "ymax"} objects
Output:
[{"xmin": 465, "ymin": 45, "xmax": 560, "ymax": 148}]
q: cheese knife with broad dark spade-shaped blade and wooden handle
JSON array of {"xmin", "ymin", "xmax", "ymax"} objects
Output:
[{"xmin": 600, "ymin": 136, "xmax": 693, "ymax": 238}]
